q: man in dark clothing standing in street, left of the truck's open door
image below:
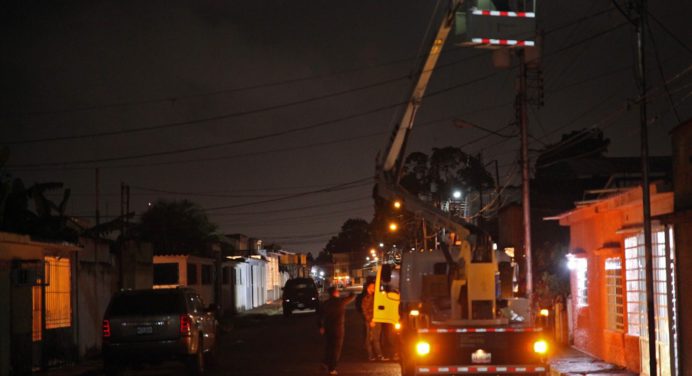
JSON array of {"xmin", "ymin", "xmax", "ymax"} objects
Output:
[{"xmin": 320, "ymin": 286, "xmax": 356, "ymax": 375}]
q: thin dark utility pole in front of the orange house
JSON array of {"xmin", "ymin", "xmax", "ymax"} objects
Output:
[{"xmin": 635, "ymin": 0, "xmax": 658, "ymax": 376}]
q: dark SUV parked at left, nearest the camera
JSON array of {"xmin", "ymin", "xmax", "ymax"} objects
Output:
[{"xmin": 103, "ymin": 288, "xmax": 216, "ymax": 375}]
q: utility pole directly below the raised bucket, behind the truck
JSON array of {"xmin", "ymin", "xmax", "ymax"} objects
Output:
[{"xmin": 515, "ymin": 48, "xmax": 533, "ymax": 300}]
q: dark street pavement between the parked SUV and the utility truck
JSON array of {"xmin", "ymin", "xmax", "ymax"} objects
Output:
[{"xmin": 96, "ymin": 294, "xmax": 401, "ymax": 376}]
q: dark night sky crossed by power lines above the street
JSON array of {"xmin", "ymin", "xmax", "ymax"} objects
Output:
[{"xmin": 0, "ymin": 0, "xmax": 692, "ymax": 254}]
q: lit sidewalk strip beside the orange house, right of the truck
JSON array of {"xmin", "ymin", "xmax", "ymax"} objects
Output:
[{"xmin": 550, "ymin": 347, "xmax": 637, "ymax": 376}]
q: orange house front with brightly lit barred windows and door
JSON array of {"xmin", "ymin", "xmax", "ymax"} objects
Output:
[{"xmin": 557, "ymin": 184, "xmax": 679, "ymax": 375}]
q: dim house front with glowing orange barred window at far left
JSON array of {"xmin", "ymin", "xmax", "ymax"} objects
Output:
[{"xmin": 0, "ymin": 232, "xmax": 80, "ymax": 376}]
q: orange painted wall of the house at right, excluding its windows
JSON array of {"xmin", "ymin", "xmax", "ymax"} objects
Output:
[{"xmin": 560, "ymin": 184, "xmax": 673, "ymax": 372}]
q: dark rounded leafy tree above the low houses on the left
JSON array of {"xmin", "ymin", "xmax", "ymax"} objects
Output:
[{"xmin": 133, "ymin": 200, "xmax": 220, "ymax": 255}]
